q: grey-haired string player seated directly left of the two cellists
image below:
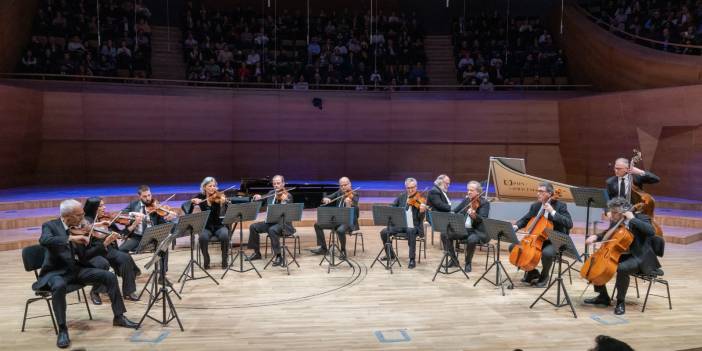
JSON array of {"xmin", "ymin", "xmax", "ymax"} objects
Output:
[{"xmin": 448, "ymin": 180, "xmax": 490, "ymax": 273}]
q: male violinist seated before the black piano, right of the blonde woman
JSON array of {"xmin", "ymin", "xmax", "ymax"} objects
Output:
[{"xmin": 247, "ymin": 175, "xmax": 295, "ymax": 266}]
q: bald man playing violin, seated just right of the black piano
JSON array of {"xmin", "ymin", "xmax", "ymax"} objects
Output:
[{"xmin": 312, "ymin": 177, "xmax": 360, "ymax": 260}]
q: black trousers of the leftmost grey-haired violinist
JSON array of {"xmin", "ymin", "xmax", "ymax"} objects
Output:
[{"xmin": 48, "ymin": 268, "xmax": 127, "ymax": 328}]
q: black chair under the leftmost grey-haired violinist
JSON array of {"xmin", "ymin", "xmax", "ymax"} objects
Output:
[{"xmin": 22, "ymin": 245, "xmax": 93, "ymax": 334}]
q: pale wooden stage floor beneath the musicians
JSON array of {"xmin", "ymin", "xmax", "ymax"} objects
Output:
[{"xmin": 0, "ymin": 227, "xmax": 702, "ymax": 350}]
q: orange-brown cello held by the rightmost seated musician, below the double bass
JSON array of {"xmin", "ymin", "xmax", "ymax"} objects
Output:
[{"xmin": 580, "ymin": 204, "xmax": 642, "ymax": 286}]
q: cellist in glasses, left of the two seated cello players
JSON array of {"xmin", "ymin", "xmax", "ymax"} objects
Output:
[{"xmin": 509, "ymin": 182, "xmax": 573, "ymax": 288}]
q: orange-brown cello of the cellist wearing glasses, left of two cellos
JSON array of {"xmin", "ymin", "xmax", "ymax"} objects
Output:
[{"xmin": 509, "ymin": 189, "xmax": 561, "ymax": 272}]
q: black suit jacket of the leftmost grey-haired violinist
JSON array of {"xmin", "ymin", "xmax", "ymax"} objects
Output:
[{"xmin": 32, "ymin": 219, "xmax": 107, "ymax": 290}]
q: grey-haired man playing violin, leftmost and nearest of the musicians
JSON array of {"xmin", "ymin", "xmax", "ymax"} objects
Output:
[{"xmin": 32, "ymin": 199, "xmax": 137, "ymax": 348}]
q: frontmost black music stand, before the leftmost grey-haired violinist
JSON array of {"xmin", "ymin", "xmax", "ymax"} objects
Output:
[{"xmin": 136, "ymin": 223, "xmax": 185, "ymax": 331}]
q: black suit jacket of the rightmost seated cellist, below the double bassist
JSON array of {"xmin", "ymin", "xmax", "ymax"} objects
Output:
[{"xmin": 597, "ymin": 213, "xmax": 661, "ymax": 274}]
